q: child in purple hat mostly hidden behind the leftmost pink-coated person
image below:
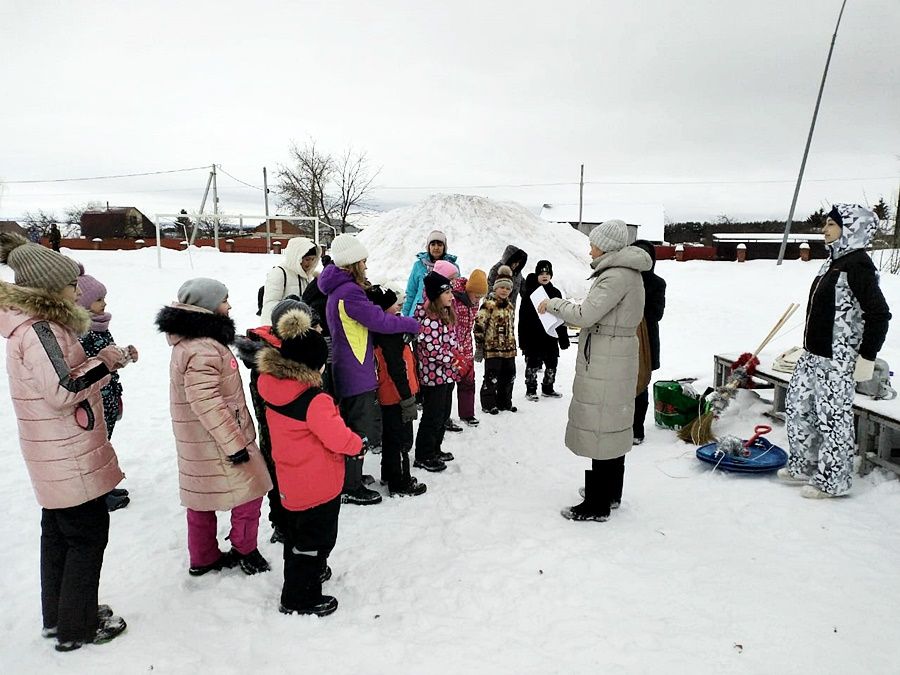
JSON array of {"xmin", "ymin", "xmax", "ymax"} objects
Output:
[{"xmin": 77, "ymin": 265, "xmax": 131, "ymax": 511}]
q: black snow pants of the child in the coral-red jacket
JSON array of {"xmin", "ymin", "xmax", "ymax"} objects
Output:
[{"xmin": 281, "ymin": 495, "xmax": 341, "ymax": 610}]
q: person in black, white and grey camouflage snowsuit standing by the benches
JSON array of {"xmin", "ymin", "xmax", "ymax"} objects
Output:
[{"xmin": 786, "ymin": 204, "xmax": 891, "ymax": 496}]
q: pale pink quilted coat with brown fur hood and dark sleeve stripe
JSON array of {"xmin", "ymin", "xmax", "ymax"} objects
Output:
[{"xmin": 0, "ymin": 282, "xmax": 124, "ymax": 509}]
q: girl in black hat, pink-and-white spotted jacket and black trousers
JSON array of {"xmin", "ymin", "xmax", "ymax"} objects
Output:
[{"xmin": 413, "ymin": 271, "xmax": 459, "ymax": 472}]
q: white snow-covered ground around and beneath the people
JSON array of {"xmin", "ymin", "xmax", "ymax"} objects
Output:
[{"xmin": 0, "ymin": 235, "xmax": 900, "ymax": 674}]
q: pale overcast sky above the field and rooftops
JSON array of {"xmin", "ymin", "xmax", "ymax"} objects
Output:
[{"xmin": 0, "ymin": 0, "xmax": 900, "ymax": 220}]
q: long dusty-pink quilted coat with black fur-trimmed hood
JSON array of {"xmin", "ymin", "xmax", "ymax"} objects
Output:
[{"xmin": 156, "ymin": 303, "xmax": 272, "ymax": 511}]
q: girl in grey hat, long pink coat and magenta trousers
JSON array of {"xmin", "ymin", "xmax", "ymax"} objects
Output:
[{"xmin": 156, "ymin": 278, "xmax": 272, "ymax": 576}]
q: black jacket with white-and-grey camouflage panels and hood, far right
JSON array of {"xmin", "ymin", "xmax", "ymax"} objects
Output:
[{"xmin": 803, "ymin": 204, "xmax": 891, "ymax": 368}]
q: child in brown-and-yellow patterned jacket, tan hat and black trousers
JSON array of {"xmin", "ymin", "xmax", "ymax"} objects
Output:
[{"xmin": 474, "ymin": 265, "xmax": 518, "ymax": 415}]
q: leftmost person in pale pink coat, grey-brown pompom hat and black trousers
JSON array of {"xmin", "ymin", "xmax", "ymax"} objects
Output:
[{"xmin": 0, "ymin": 233, "xmax": 137, "ymax": 651}]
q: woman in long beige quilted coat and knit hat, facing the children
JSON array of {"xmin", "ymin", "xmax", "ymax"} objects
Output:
[{"xmin": 538, "ymin": 220, "xmax": 651, "ymax": 521}]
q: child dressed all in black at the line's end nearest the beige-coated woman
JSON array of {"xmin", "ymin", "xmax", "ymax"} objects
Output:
[{"xmin": 519, "ymin": 260, "xmax": 569, "ymax": 401}]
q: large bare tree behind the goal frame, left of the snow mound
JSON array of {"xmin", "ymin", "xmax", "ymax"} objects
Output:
[{"xmin": 275, "ymin": 140, "xmax": 378, "ymax": 232}]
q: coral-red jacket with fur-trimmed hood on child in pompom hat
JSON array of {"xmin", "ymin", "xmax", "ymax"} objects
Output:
[{"xmin": 257, "ymin": 347, "xmax": 362, "ymax": 511}]
